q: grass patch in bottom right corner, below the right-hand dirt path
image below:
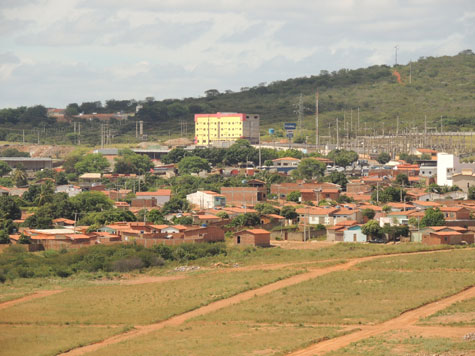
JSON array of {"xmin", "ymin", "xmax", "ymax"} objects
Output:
[{"xmin": 325, "ymin": 333, "xmax": 475, "ymax": 356}]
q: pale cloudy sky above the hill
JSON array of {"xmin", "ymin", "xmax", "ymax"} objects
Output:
[{"xmin": 0, "ymin": 0, "xmax": 475, "ymax": 108}]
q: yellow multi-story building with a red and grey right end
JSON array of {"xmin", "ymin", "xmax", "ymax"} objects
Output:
[{"xmin": 195, "ymin": 112, "xmax": 259, "ymax": 146}]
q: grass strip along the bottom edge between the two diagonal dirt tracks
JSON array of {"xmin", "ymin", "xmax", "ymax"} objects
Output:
[{"xmin": 88, "ymin": 321, "xmax": 339, "ymax": 356}]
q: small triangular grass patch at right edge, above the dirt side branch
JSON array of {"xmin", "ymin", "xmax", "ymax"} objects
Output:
[{"xmin": 420, "ymin": 298, "xmax": 475, "ymax": 326}]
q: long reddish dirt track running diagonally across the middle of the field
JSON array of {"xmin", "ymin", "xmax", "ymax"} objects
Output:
[{"xmin": 55, "ymin": 250, "xmax": 462, "ymax": 356}]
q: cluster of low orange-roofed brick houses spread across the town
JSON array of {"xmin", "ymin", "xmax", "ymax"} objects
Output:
[{"xmin": 0, "ymin": 142, "xmax": 475, "ymax": 250}]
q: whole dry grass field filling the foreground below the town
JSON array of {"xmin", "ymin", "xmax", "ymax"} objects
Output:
[{"xmin": 0, "ymin": 244, "xmax": 475, "ymax": 356}]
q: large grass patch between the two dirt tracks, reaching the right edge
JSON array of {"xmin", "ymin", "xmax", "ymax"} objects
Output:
[{"xmin": 200, "ymin": 271, "xmax": 475, "ymax": 324}]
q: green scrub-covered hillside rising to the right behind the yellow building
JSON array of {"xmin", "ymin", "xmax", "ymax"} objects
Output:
[{"xmin": 0, "ymin": 50, "xmax": 475, "ymax": 142}]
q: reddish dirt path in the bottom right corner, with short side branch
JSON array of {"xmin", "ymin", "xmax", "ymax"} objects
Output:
[{"xmin": 289, "ymin": 287, "xmax": 475, "ymax": 356}]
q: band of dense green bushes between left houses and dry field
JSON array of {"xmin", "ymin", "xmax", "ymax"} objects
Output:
[{"xmin": 0, "ymin": 243, "xmax": 228, "ymax": 283}]
